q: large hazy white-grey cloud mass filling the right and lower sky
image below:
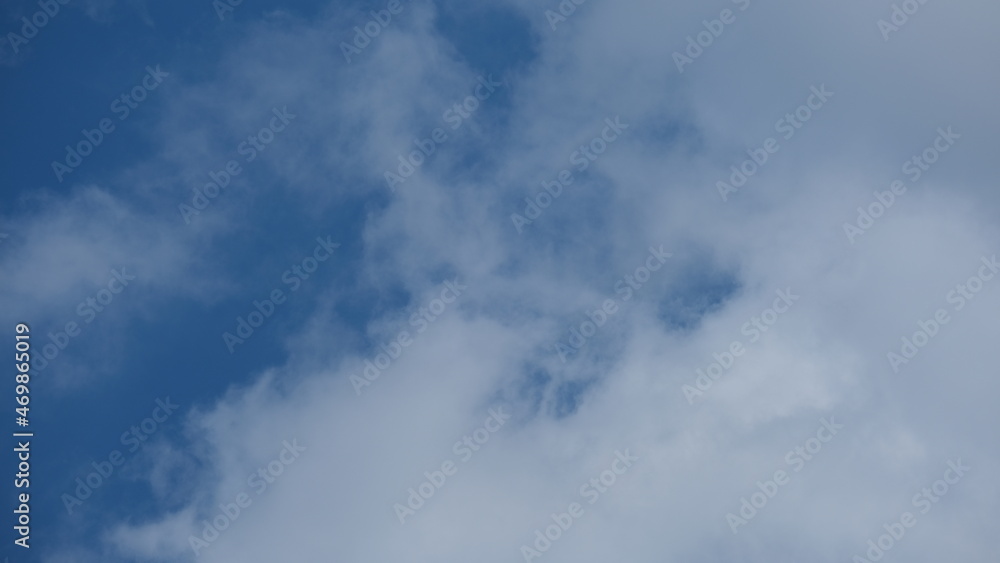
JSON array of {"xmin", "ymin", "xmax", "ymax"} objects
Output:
[{"xmin": 23, "ymin": 1, "xmax": 1000, "ymax": 563}]
